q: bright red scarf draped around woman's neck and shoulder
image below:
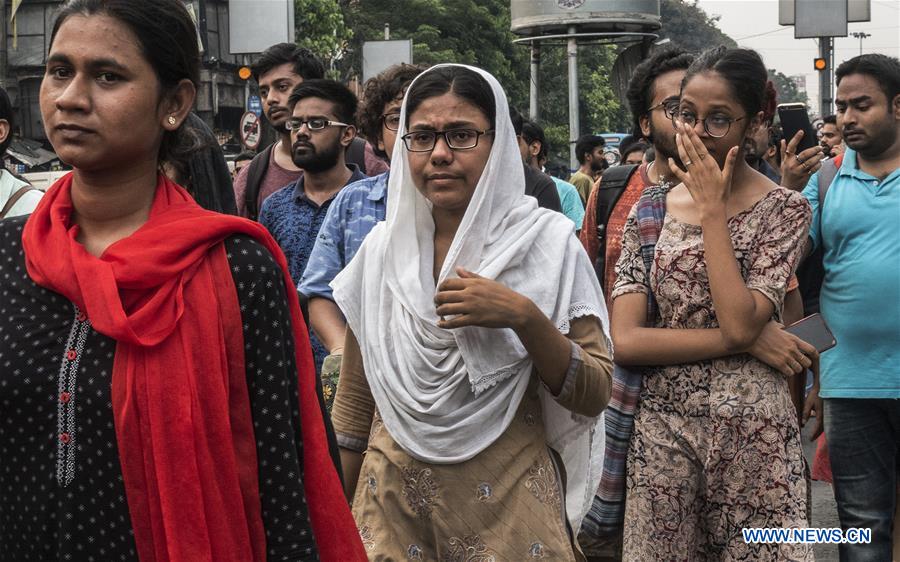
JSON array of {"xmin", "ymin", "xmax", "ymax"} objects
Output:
[{"xmin": 22, "ymin": 174, "xmax": 366, "ymax": 562}]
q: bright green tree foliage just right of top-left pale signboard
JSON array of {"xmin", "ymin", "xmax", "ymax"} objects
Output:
[{"xmin": 294, "ymin": 0, "xmax": 353, "ymax": 69}]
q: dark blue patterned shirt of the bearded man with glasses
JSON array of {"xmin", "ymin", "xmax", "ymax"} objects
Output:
[{"xmin": 259, "ymin": 164, "xmax": 366, "ymax": 372}]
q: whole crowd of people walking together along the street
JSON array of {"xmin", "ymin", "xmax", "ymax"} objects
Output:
[{"xmin": 0, "ymin": 0, "xmax": 900, "ymax": 562}]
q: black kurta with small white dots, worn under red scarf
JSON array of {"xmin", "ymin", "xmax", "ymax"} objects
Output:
[{"xmin": 0, "ymin": 213, "xmax": 317, "ymax": 562}]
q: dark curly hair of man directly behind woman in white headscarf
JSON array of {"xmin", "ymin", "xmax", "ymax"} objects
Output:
[{"xmin": 356, "ymin": 63, "xmax": 428, "ymax": 157}]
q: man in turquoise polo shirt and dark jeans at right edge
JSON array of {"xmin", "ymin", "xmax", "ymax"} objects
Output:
[{"xmin": 800, "ymin": 54, "xmax": 900, "ymax": 561}]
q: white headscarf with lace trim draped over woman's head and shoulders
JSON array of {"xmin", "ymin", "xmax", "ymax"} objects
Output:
[{"xmin": 331, "ymin": 65, "xmax": 609, "ymax": 530}]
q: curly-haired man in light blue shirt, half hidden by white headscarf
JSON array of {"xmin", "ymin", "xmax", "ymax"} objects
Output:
[{"xmin": 295, "ymin": 64, "xmax": 424, "ymax": 411}]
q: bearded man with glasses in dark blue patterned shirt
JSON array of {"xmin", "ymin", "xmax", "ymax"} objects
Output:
[{"xmin": 259, "ymin": 79, "xmax": 366, "ymax": 372}]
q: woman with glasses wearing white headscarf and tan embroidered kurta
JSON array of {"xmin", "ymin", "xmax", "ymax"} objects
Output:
[{"xmin": 332, "ymin": 65, "xmax": 612, "ymax": 561}]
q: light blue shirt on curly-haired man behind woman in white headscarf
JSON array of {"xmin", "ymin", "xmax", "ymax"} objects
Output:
[{"xmin": 297, "ymin": 172, "xmax": 390, "ymax": 300}]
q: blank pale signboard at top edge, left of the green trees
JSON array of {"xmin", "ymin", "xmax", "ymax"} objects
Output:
[{"xmin": 228, "ymin": 0, "xmax": 294, "ymax": 55}]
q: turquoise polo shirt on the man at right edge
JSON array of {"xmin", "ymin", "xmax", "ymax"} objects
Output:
[{"xmin": 803, "ymin": 149, "xmax": 900, "ymax": 398}]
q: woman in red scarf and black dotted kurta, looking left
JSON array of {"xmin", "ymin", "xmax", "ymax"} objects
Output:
[{"xmin": 0, "ymin": 0, "xmax": 365, "ymax": 562}]
